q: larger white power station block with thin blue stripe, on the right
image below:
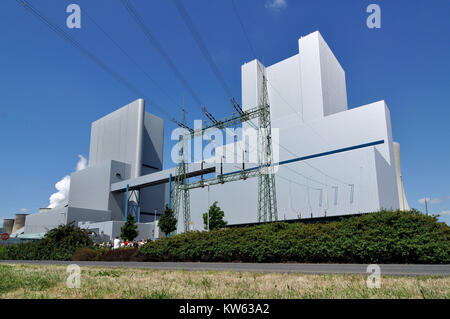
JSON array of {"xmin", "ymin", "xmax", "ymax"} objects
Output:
[{"xmin": 185, "ymin": 32, "xmax": 409, "ymax": 228}]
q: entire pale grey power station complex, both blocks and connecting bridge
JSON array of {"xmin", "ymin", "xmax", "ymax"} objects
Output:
[{"xmin": 3, "ymin": 32, "xmax": 409, "ymax": 239}]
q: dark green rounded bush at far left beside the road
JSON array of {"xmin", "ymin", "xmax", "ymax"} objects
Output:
[{"xmin": 4, "ymin": 223, "xmax": 93, "ymax": 260}]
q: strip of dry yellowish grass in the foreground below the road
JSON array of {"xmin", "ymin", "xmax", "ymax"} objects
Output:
[{"xmin": 0, "ymin": 264, "xmax": 450, "ymax": 299}]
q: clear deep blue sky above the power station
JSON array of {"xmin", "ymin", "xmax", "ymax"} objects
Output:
[{"xmin": 0, "ymin": 0, "xmax": 450, "ymax": 223}]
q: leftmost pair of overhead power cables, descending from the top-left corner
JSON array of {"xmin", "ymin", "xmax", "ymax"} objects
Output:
[{"xmin": 16, "ymin": 0, "xmax": 174, "ymax": 122}]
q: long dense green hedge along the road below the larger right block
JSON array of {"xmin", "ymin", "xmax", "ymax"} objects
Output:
[{"xmin": 139, "ymin": 210, "xmax": 450, "ymax": 264}]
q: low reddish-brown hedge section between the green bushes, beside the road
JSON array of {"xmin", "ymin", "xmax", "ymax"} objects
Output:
[{"xmin": 72, "ymin": 248, "xmax": 143, "ymax": 261}]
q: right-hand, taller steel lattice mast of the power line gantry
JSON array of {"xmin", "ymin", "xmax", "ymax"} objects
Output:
[{"xmin": 258, "ymin": 74, "xmax": 278, "ymax": 222}]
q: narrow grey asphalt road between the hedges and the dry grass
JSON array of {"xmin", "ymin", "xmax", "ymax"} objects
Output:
[{"xmin": 0, "ymin": 260, "xmax": 450, "ymax": 276}]
